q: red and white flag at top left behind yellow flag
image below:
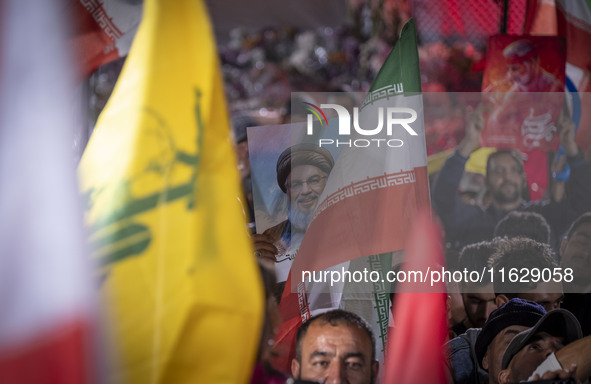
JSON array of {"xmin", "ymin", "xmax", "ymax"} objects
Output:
[{"xmin": 68, "ymin": 0, "xmax": 142, "ymax": 78}]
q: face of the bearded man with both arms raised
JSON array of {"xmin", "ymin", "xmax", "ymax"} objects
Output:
[{"xmin": 486, "ymin": 154, "xmax": 525, "ymax": 203}]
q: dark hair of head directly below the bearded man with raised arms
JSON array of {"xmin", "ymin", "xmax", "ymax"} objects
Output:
[{"xmin": 494, "ymin": 211, "xmax": 550, "ymax": 244}]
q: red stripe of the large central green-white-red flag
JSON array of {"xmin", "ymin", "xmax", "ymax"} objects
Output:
[{"xmin": 287, "ymin": 167, "xmax": 429, "ymax": 282}]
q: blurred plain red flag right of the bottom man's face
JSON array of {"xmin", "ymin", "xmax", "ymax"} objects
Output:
[{"xmin": 383, "ymin": 212, "xmax": 447, "ymax": 384}]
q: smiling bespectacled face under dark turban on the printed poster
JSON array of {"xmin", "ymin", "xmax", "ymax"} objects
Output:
[{"xmin": 286, "ymin": 165, "xmax": 328, "ymax": 214}]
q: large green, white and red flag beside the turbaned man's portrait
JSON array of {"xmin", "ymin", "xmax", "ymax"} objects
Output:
[{"xmin": 274, "ymin": 20, "xmax": 430, "ymax": 372}]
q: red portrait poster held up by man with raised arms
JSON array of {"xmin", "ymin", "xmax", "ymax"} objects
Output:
[{"xmin": 480, "ymin": 35, "xmax": 566, "ymax": 152}]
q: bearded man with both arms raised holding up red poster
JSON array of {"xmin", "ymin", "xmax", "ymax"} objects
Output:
[{"xmin": 431, "ymin": 103, "xmax": 591, "ymax": 248}]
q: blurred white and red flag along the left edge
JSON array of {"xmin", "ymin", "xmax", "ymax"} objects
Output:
[{"xmin": 0, "ymin": 0, "xmax": 94, "ymax": 384}]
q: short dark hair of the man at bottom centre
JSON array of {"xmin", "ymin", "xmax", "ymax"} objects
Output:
[{"xmin": 296, "ymin": 309, "xmax": 376, "ymax": 363}]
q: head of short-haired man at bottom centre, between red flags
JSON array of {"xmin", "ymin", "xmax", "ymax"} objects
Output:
[{"xmin": 291, "ymin": 309, "xmax": 379, "ymax": 384}]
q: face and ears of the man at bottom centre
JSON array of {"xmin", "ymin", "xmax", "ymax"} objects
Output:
[{"xmin": 291, "ymin": 322, "xmax": 378, "ymax": 384}]
